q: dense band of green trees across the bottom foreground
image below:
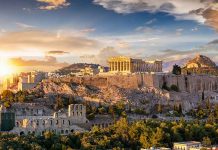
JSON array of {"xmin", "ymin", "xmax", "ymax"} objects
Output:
[{"xmin": 0, "ymin": 118, "xmax": 218, "ymax": 150}]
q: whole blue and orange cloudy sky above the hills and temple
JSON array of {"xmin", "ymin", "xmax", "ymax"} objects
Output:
[{"xmin": 0, "ymin": 0, "xmax": 218, "ymax": 70}]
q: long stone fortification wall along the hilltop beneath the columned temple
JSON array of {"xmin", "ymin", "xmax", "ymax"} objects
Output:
[{"xmin": 50, "ymin": 73, "xmax": 218, "ymax": 92}]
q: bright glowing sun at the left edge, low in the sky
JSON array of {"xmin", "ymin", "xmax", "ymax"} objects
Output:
[{"xmin": 0, "ymin": 58, "xmax": 14, "ymax": 77}]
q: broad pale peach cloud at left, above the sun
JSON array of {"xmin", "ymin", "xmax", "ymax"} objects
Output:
[{"xmin": 0, "ymin": 29, "xmax": 100, "ymax": 56}]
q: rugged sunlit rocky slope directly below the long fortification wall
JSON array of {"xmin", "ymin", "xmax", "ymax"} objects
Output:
[{"xmin": 29, "ymin": 78, "xmax": 204, "ymax": 112}]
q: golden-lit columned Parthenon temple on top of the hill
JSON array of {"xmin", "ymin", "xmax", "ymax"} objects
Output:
[{"xmin": 108, "ymin": 56, "xmax": 162, "ymax": 73}]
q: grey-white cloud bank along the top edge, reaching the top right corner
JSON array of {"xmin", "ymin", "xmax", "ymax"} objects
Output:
[{"xmin": 93, "ymin": 0, "xmax": 218, "ymax": 30}]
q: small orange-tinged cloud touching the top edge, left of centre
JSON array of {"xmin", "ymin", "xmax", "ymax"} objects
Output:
[{"xmin": 37, "ymin": 0, "xmax": 70, "ymax": 10}]
